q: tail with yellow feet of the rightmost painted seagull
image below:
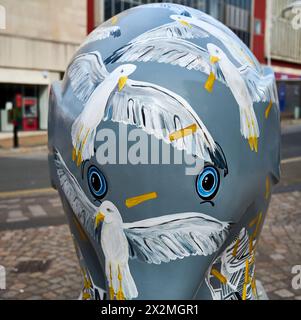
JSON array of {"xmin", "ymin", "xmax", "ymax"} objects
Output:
[{"xmin": 240, "ymin": 106, "xmax": 259, "ymax": 152}]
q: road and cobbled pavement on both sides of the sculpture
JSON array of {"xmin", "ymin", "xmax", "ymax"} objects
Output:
[{"xmin": 0, "ymin": 130, "xmax": 301, "ymax": 300}]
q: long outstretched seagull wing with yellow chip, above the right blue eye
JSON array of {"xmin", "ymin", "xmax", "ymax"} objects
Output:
[{"xmin": 104, "ymin": 80, "xmax": 216, "ymax": 161}]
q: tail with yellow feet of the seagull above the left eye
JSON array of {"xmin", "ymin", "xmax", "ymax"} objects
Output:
[{"xmin": 71, "ymin": 115, "xmax": 95, "ymax": 166}]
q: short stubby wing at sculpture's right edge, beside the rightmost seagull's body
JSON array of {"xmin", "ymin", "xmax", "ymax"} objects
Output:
[{"xmin": 239, "ymin": 66, "xmax": 278, "ymax": 103}]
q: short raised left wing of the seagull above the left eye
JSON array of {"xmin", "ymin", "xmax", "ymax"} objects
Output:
[{"xmin": 64, "ymin": 51, "xmax": 109, "ymax": 103}]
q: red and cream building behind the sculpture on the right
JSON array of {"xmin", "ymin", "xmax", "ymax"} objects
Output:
[{"xmin": 253, "ymin": 0, "xmax": 301, "ymax": 117}]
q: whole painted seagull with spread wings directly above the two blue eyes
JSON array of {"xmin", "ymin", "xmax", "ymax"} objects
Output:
[{"xmin": 67, "ymin": 51, "xmax": 218, "ymax": 165}]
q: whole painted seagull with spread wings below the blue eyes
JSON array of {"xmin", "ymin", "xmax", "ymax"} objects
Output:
[{"xmin": 54, "ymin": 150, "xmax": 230, "ymax": 300}]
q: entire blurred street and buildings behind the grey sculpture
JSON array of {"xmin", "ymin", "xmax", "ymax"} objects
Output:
[{"xmin": 0, "ymin": 0, "xmax": 301, "ymax": 300}]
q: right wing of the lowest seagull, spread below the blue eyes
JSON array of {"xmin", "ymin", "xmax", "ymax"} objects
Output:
[{"xmin": 123, "ymin": 212, "xmax": 230, "ymax": 264}]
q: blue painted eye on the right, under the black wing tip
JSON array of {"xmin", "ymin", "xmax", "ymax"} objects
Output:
[{"xmin": 196, "ymin": 166, "xmax": 220, "ymax": 200}]
